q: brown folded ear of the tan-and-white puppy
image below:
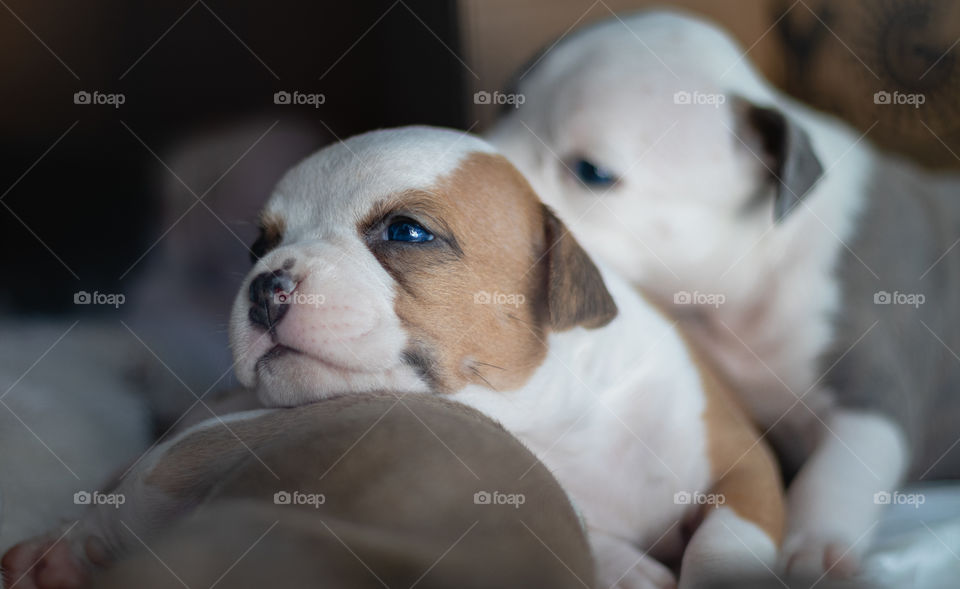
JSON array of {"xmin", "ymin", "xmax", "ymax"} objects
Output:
[{"xmin": 543, "ymin": 205, "xmax": 617, "ymax": 331}]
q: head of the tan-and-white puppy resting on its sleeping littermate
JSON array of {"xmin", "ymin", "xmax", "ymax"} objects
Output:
[{"xmin": 230, "ymin": 127, "xmax": 616, "ymax": 406}]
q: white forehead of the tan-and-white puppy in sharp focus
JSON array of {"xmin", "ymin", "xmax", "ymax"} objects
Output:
[{"xmin": 266, "ymin": 127, "xmax": 498, "ymax": 237}]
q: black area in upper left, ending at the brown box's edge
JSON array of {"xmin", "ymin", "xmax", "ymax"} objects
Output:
[{"xmin": 0, "ymin": 0, "xmax": 465, "ymax": 313}]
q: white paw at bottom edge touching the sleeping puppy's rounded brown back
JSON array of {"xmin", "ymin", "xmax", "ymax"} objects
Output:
[{"xmin": 590, "ymin": 530, "xmax": 677, "ymax": 589}]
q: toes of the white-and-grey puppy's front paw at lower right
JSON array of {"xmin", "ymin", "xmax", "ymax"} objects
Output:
[{"xmin": 780, "ymin": 536, "xmax": 860, "ymax": 579}]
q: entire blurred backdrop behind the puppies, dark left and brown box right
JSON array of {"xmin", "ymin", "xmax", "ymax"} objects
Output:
[{"xmin": 0, "ymin": 0, "xmax": 960, "ymax": 312}]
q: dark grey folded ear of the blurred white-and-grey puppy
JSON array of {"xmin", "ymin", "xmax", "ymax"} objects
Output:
[{"xmin": 734, "ymin": 99, "xmax": 823, "ymax": 222}]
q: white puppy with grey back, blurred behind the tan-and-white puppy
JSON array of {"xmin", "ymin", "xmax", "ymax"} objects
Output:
[{"xmin": 488, "ymin": 12, "xmax": 960, "ymax": 575}]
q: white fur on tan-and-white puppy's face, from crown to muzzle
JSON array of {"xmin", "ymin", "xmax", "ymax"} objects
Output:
[{"xmin": 230, "ymin": 127, "xmax": 493, "ymax": 406}]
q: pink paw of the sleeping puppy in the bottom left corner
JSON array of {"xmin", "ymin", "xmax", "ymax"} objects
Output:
[{"xmin": 0, "ymin": 535, "xmax": 90, "ymax": 589}]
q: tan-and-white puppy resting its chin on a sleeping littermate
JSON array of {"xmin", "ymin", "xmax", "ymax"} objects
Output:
[{"xmin": 231, "ymin": 127, "xmax": 782, "ymax": 587}]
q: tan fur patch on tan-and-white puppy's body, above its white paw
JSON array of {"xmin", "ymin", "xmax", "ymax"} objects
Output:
[{"xmin": 688, "ymin": 342, "xmax": 786, "ymax": 546}]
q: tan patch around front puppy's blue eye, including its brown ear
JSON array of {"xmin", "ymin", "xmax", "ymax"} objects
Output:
[{"xmin": 360, "ymin": 153, "xmax": 616, "ymax": 392}]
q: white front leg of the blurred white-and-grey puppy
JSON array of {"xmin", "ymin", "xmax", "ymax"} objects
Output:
[{"xmin": 781, "ymin": 411, "xmax": 908, "ymax": 577}]
